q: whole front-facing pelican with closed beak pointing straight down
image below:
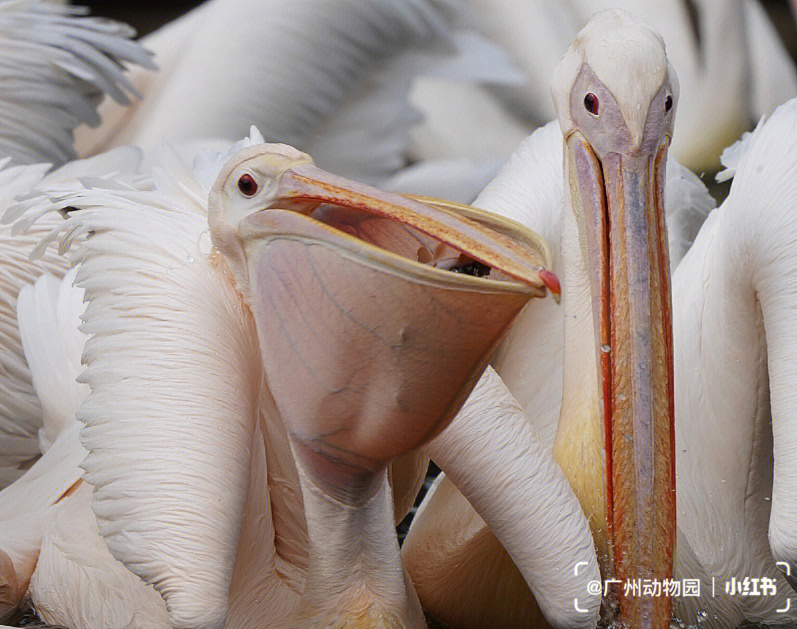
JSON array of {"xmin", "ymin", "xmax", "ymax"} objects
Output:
[{"xmin": 403, "ymin": 11, "xmax": 678, "ymax": 627}]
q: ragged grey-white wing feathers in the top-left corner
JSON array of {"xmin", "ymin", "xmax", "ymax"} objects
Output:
[{"xmin": 0, "ymin": 0, "xmax": 154, "ymax": 164}]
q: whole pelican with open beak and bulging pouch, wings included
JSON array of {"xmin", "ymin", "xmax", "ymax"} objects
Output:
[{"xmin": 1, "ymin": 136, "xmax": 597, "ymax": 627}]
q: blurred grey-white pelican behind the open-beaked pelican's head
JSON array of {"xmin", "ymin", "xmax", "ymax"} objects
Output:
[{"xmin": 71, "ymin": 0, "xmax": 522, "ymax": 202}]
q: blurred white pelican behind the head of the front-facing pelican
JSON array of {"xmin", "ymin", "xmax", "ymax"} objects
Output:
[{"xmin": 411, "ymin": 0, "xmax": 797, "ymax": 173}]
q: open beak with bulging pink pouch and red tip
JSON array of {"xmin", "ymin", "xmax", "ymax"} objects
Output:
[{"xmin": 239, "ymin": 162, "xmax": 559, "ymax": 501}]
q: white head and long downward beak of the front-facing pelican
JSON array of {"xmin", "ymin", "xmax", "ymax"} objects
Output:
[{"xmin": 553, "ymin": 10, "xmax": 678, "ymax": 627}]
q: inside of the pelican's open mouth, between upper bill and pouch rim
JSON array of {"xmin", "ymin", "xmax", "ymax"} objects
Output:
[{"xmin": 310, "ymin": 204, "xmax": 510, "ymax": 280}]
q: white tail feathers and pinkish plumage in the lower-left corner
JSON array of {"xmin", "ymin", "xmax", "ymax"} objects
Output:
[{"xmin": 0, "ymin": 270, "xmax": 169, "ymax": 629}]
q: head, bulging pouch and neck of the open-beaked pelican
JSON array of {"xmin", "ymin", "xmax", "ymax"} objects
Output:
[{"xmin": 208, "ymin": 145, "xmax": 559, "ymax": 627}]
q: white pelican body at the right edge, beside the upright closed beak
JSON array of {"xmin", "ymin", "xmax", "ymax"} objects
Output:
[{"xmin": 673, "ymin": 95, "xmax": 797, "ymax": 628}]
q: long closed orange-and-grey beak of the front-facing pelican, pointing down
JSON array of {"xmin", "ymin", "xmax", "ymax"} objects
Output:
[{"xmin": 566, "ymin": 132, "xmax": 675, "ymax": 628}]
